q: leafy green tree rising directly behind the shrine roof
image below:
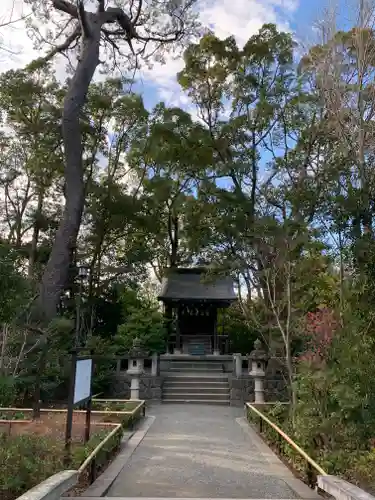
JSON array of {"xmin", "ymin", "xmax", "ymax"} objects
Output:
[{"xmin": 128, "ymin": 103, "xmax": 212, "ymax": 280}]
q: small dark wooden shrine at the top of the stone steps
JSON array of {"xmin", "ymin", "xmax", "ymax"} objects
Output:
[{"xmin": 158, "ymin": 268, "xmax": 237, "ymax": 356}]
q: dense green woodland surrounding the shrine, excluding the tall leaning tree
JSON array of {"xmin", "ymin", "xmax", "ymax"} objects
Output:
[{"xmin": 0, "ymin": 2, "xmax": 375, "ymax": 488}]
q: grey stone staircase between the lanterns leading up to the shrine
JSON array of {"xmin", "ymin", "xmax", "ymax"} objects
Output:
[{"xmin": 163, "ymin": 359, "xmax": 230, "ymax": 405}]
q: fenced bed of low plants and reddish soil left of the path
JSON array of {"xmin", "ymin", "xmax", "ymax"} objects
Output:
[{"xmin": 0, "ymin": 401, "xmax": 143, "ymax": 500}]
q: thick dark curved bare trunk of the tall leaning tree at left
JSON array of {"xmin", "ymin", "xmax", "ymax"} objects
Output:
[{"xmin": 37, "ymin": 22, "xmax": 101, "ymax": 321}]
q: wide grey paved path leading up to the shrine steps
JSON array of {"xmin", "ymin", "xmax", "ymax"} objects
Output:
[{"xmin": 106, "ymin": 404, "xmax": 316, "ymax": 499}]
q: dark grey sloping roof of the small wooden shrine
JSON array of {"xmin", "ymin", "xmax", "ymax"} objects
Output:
[{"xmin": 158, "ymin": 268, "xmax": 237, "ymax": 302}]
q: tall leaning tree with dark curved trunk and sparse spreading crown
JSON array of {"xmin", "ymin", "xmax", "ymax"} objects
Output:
[{"xmin": 28, "ymin": 0, "xmax": 203, "ymax": 321}]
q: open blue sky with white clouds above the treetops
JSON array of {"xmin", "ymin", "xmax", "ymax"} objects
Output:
[{"xmin": 0, "ymin": 0, "xmax": 357, "ymax": 118}]
